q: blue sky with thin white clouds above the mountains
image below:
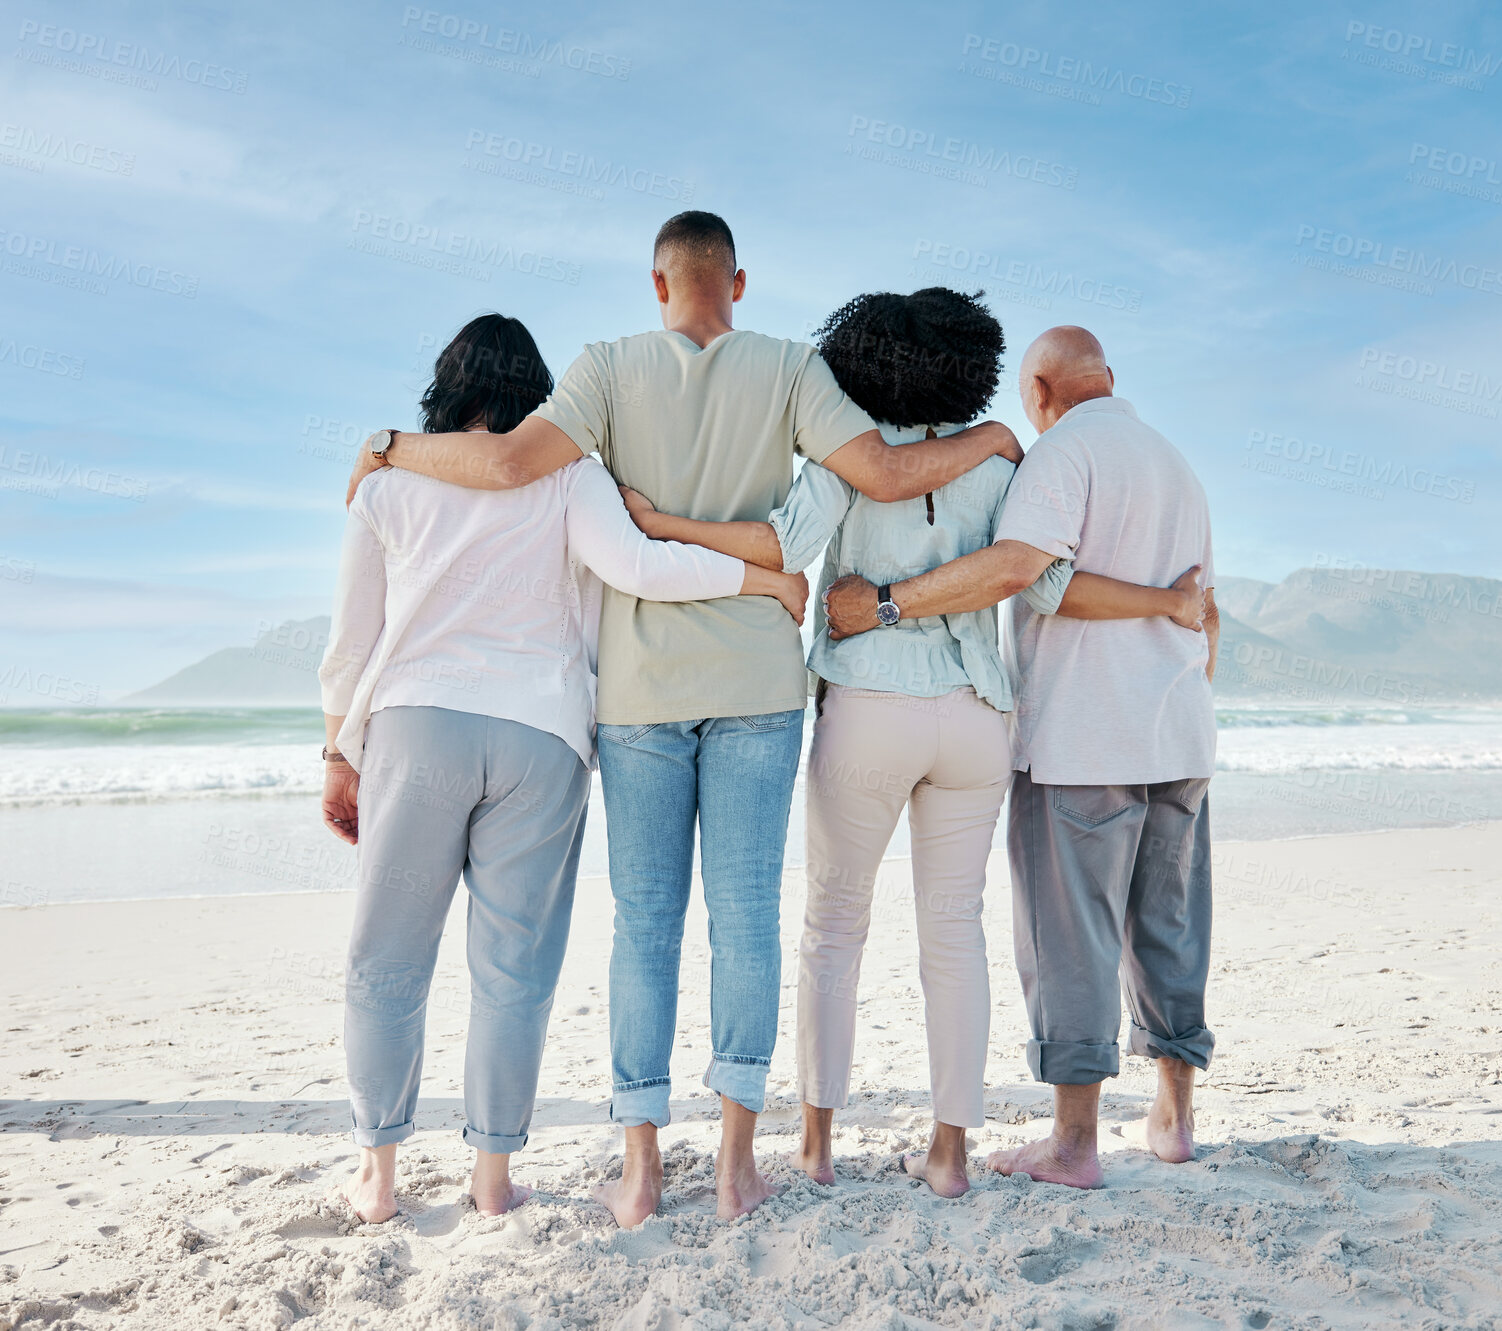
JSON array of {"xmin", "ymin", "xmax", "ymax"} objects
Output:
[{"xmin": 0, "ymin": 0, "xmax": 1502, "ymax": 706}]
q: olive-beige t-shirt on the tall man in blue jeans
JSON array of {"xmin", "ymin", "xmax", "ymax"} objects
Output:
[{"xmin": 536, "ymin": 329, "xmax": 876, "ymax": 726}]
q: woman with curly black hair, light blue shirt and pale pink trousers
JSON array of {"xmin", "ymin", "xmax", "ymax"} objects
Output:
[{"xmin": 626, "ymin": 287, "xmax": 1202, "ymax": 1197}]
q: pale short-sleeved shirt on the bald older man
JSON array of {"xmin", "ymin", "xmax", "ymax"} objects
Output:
[{"xmin": 997, "ymin": 397, "xmax": 1215, "ymax": 786}]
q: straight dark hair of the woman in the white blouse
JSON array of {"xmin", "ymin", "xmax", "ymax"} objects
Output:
[{"xmin": 422, "ymin": 314, "xmax": 553, "ymax": 434}]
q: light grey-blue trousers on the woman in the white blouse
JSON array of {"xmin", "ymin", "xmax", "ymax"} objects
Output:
[{"xmin": 344, "ymin": 708, "xmax": 589, "ymax": 1154}]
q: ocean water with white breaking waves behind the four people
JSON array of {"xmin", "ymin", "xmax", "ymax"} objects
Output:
[{"xmin": 0, "ymin": 705, "xmax": 1502, "ymax": 906}]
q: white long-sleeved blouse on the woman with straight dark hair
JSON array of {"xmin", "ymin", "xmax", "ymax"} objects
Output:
[{"xmin": 318, "ymin": 458, "xmax": 745, "ymax": 769}]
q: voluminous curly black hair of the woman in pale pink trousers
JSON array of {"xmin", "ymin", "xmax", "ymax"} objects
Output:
[{"xmin": 814, "ymin": 287, "xmax": 1006, "ymax": 425}]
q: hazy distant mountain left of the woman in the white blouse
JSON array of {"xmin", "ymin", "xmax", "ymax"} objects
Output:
[{"xmin": 122, "ymin": 614, "xmax": 329, "ymax": 708}]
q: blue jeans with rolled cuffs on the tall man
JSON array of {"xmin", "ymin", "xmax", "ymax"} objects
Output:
[{"xmin": 599, "ymin": 712, "xmax": 804, "ymax": 1128}]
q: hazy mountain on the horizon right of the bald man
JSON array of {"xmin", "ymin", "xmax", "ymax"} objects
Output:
[{"xmin": 1215, "ymin": 568, "xmax": 1502, "ymax": 706}]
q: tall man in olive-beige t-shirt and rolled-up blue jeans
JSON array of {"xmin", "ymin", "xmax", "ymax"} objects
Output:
[{"xmin": 351, "ymin": 212, "xmax": 1021, "ymax": 1226}]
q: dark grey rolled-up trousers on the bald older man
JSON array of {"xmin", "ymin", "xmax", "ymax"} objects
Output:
[{"xmin": 1006, "ymin": 772, "xmax": 1215, "ymax": 1086}]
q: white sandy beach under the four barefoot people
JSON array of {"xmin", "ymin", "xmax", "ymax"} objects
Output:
[{"xmin": 0, "ymin": 823, "xmax": 1502, "ymax": 1331}]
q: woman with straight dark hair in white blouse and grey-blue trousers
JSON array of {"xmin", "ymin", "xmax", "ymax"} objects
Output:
[{"xmin": 318, "ymin": 314, "xmax": 808, "ymax": 1223}]
